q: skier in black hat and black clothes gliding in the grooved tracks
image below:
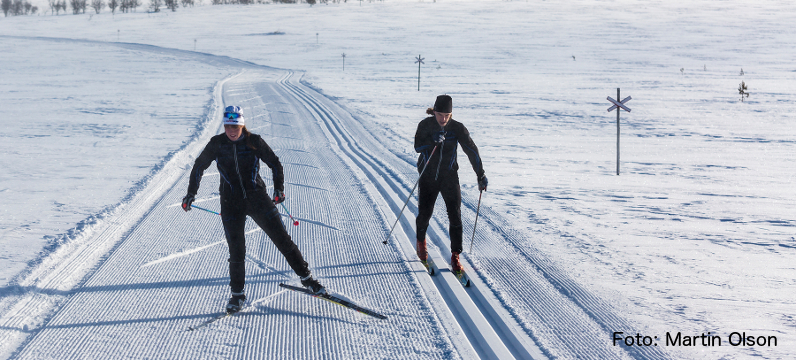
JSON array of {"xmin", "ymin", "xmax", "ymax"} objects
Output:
[{"xmin": 415, "ymin": 95, "xmax": 488, "ymax": 272}]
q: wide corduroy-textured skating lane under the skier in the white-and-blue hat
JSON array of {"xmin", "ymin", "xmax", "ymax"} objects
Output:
[{"xmin": 0, "ymin": 65, "xmax": 474, "ymax": 359}]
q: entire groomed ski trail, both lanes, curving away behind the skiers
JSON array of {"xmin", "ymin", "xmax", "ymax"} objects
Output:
[{"xmin": 0, "ymin": 38, "xmax": 668, "ymax": 359}]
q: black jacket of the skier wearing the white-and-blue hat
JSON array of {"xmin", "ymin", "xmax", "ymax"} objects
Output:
[{"xmin": 188, "ymin": 134, "xmax": 285, "ymax": 198}]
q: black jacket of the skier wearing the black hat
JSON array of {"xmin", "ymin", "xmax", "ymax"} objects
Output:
[{"xmin": 415, "ymin": 116, "xmax": 484, "ymax": 179}]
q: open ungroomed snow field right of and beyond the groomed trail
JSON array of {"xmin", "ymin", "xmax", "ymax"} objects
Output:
[{"xmin": 0, "ymin": 1, "xmax": 796, "ymax": 358}]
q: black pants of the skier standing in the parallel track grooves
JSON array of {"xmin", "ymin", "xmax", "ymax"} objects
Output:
[{"xmin": 416, "ymin": 169, "xmax": 462, "ymax": 253}]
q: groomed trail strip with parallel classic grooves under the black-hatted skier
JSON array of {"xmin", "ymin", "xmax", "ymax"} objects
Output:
[{"xmin": 274, "ymin": 71, "xmax": 669, "ymax": 359}]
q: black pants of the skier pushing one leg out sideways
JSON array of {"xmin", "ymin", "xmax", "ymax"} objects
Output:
[{"xmin": 221, "ymin": 191, "xmax": 310, "ymax": 293}]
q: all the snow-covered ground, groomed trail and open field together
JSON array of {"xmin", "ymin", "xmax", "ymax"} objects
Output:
[{"xmin": 0, "ymin": 1, "xmax": 796, "ymax": 359}]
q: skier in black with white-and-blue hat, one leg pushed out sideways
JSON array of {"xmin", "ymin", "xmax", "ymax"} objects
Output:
[{"xmin": 182, "ymin": 106, "xmax": 326, "ymax": 313}]
